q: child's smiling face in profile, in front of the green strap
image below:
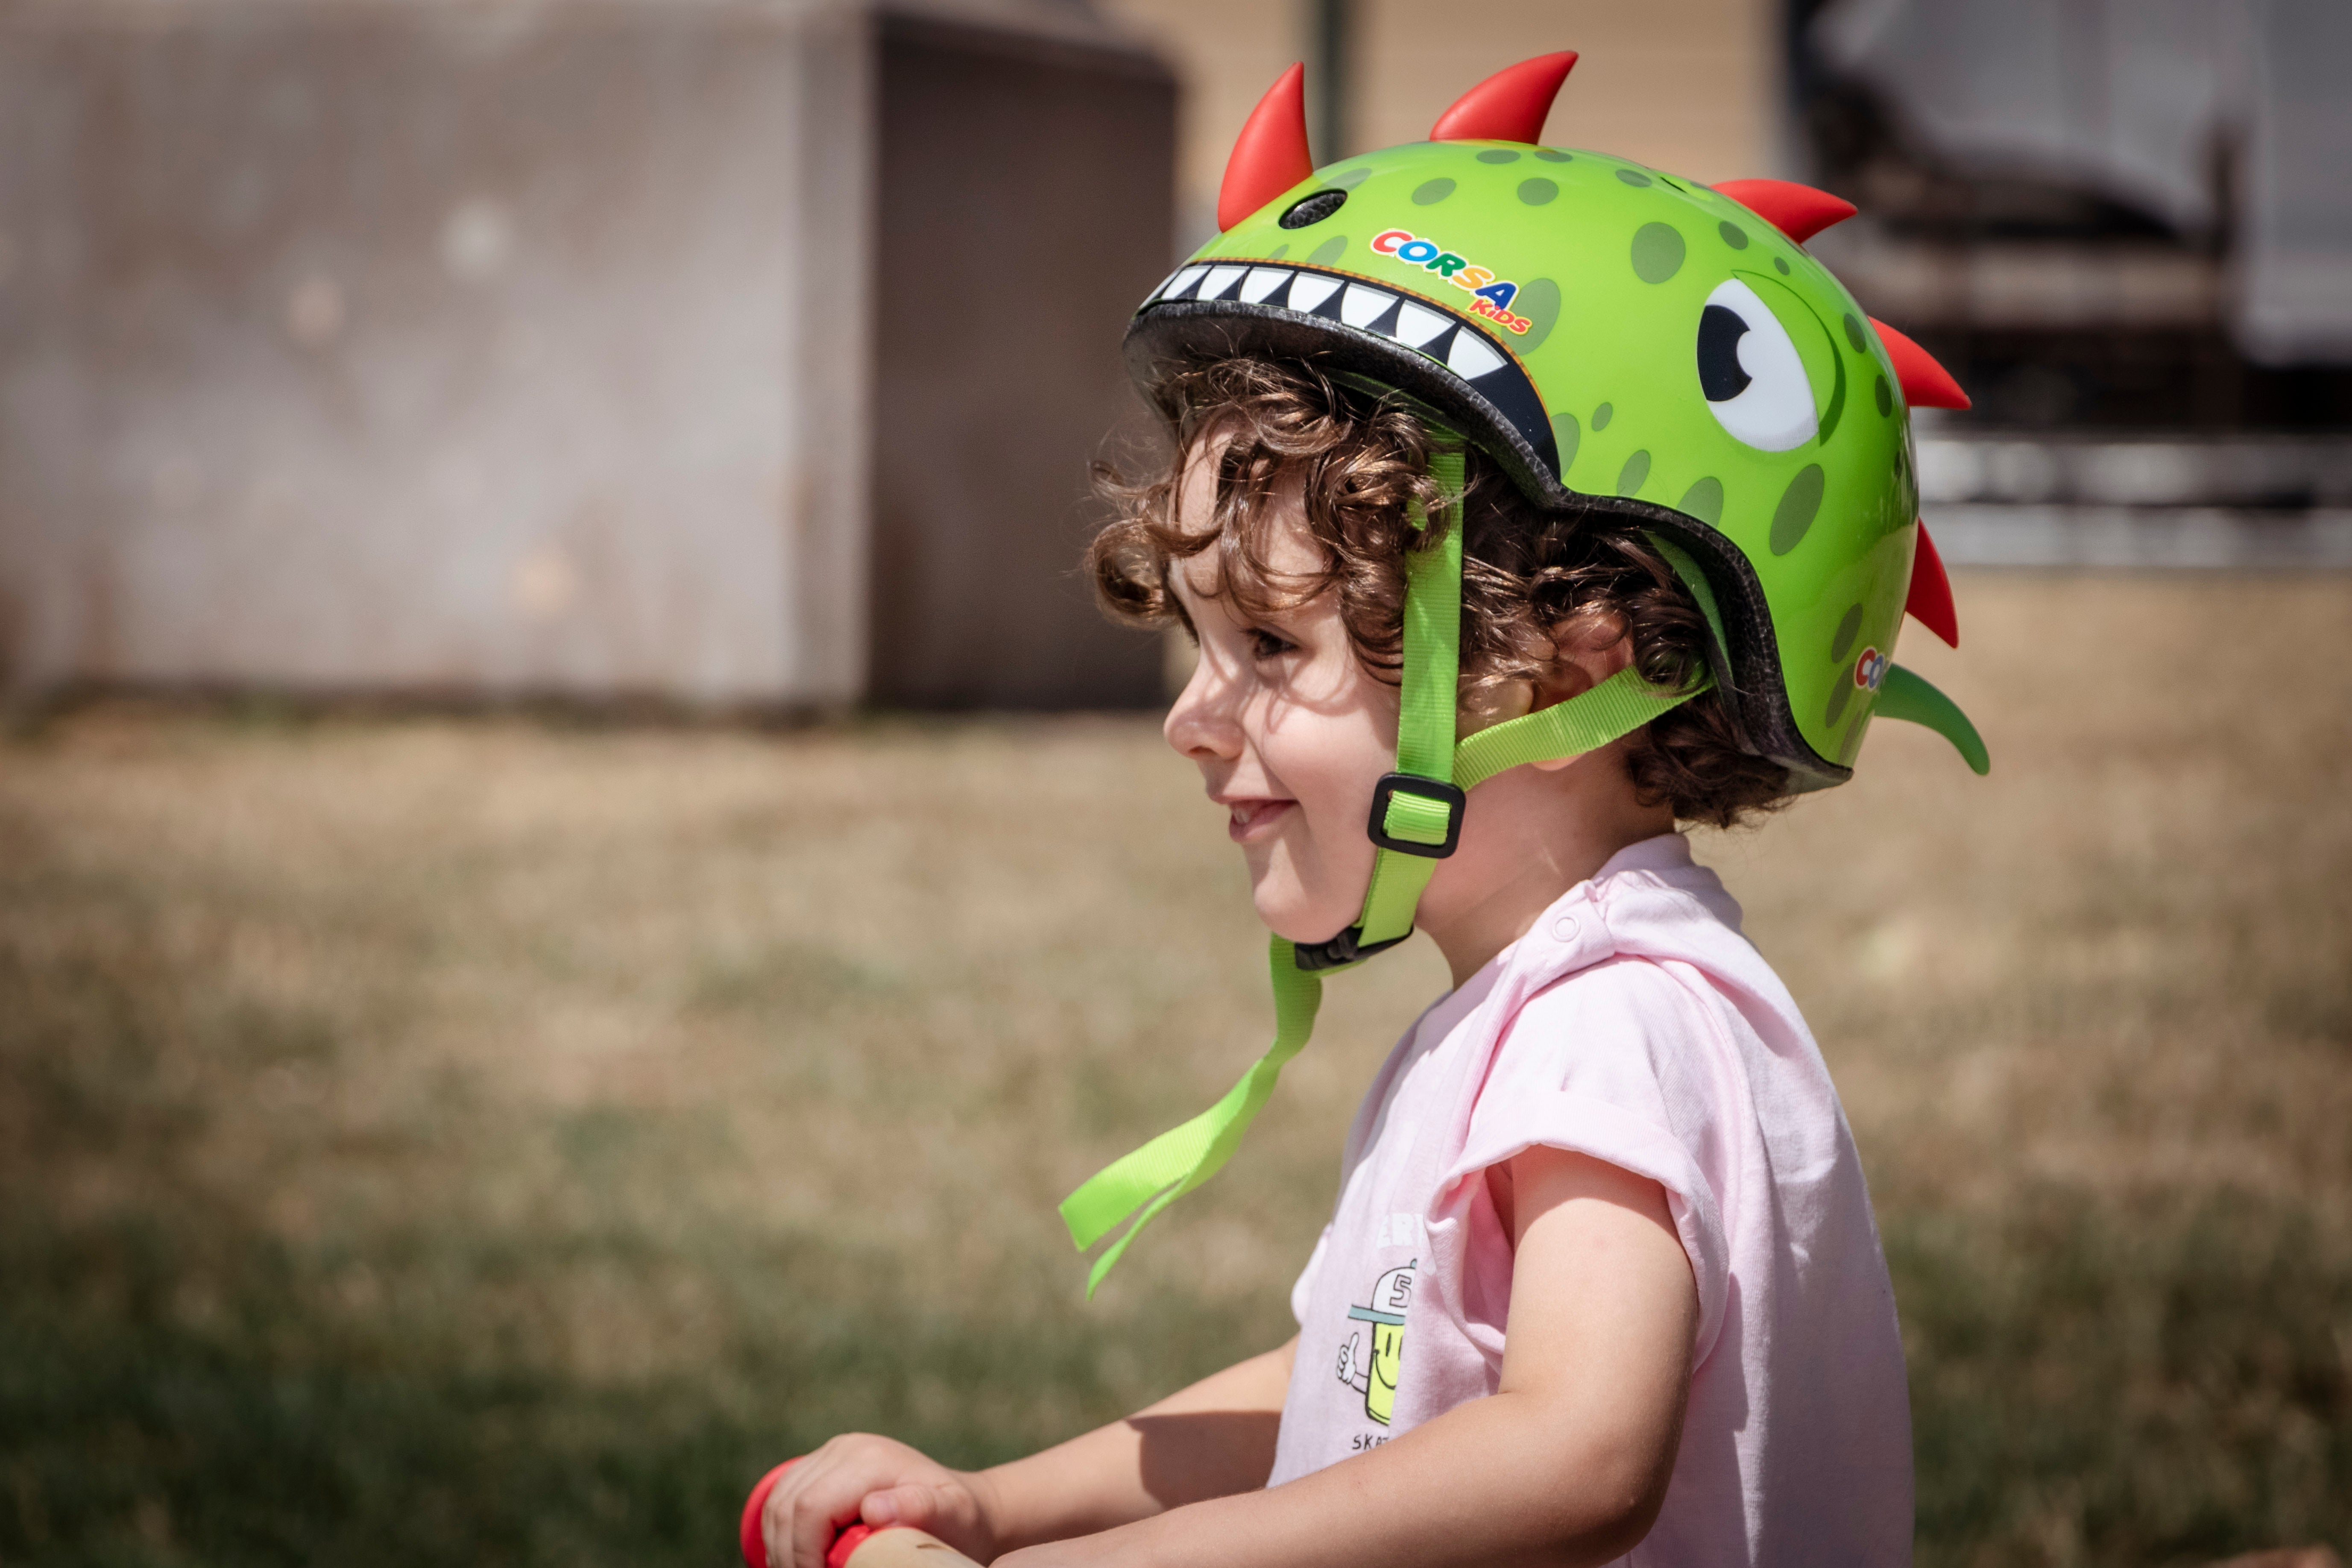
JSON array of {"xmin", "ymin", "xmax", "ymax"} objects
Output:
[{"xmin": 1166, "ymin": 444, "xmax": 1397, "ymax": 943}]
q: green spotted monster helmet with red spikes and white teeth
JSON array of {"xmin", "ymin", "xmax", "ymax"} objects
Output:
[{"xmin": 1127, "ymin": 54, "xmax": 1987, "ymax": 790}]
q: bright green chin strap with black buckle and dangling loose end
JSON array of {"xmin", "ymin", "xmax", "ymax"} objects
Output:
[{"xmin": 1061, "ymin": 447, "xmax": 1722, "ymax": 1300}]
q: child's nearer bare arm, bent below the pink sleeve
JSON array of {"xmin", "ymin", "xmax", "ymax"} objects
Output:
[{"xmin": 1004, "ymin": 1149, "xmax": 1698, "ymax": 1568}]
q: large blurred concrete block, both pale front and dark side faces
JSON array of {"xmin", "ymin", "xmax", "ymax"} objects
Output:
[{"xmin": 0, "ymin": 0, "xmax": 1174, "ymax": 705}]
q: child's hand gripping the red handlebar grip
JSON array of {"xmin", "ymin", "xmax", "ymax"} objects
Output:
[{"xmin": 760, "ymin": 1432, "xmax": 997, "ymax": 1568}]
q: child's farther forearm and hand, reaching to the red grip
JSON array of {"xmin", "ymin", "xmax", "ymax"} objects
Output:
[{"xmin": 760, "ymin": 1340, "xmax": 1298, "ymax": 1568}]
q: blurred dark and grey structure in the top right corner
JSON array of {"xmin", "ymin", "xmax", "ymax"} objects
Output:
[{"xmin": 1787, "ymin": 0, "xmax": 2352, "ymax": 566}]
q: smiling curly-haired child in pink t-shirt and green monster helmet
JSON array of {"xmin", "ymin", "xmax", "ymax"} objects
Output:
[{"xmin": 762, "ymin": 56, "xmax": 1983, "ymax": 1568}]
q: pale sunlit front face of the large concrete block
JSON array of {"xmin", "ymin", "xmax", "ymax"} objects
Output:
[{"xmin": 0, "ymin": 0, "xmax": 868, "ymax": 700}]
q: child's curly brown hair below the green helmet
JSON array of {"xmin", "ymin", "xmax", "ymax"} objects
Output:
[{"xmin": 1087, "ymin": 358, "xmax": 1790, "ymax": 827}]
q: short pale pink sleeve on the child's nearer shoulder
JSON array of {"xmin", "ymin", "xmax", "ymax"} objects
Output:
[{"xmin": 1439, "ymin": 957, "xmax": 1736, "ymax": 1359}]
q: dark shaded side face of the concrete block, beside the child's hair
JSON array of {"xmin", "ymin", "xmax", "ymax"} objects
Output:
[{"xmin": 870, "ymin": 17, "xmax": 1176, "ymax": 708}]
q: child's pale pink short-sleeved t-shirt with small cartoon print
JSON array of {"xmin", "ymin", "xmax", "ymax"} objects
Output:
[{"xmin": 1270, "ymin": 835, "xmax": 1912, "ymax": 1568}]
